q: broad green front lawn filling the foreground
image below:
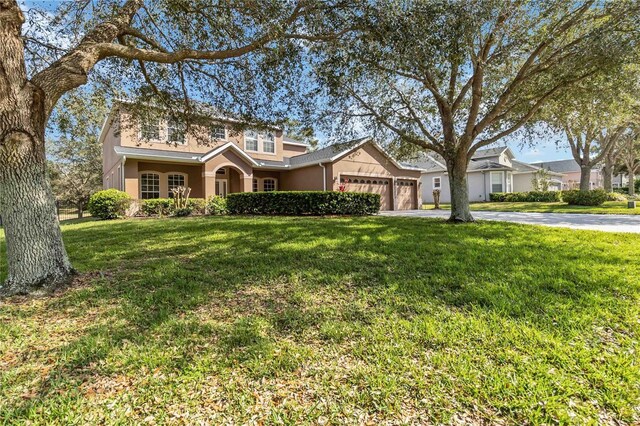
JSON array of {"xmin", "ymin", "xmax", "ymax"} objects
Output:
[{"xmin": 0, "ymin": 217, "xmax": 640, "ymax": 424}]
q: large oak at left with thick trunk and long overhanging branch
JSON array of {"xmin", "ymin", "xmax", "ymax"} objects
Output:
[{"xmin": 0, "ymin": 0, "xmax": 350, "ymax": 294}]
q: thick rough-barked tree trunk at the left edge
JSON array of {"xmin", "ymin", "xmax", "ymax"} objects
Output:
[{"xmin": 0, "ymin": 1, "xmax": 73, "ymax": 295}]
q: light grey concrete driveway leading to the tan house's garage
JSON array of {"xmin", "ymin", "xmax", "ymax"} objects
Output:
[{"xmin": 380, "ymin": 210, "xmax": 640, "ymax": 234}]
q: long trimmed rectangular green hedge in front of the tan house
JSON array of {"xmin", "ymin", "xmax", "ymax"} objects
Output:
[{"xmin": 227, "ymin": 191, "xmax": 380, "ymax": 216}]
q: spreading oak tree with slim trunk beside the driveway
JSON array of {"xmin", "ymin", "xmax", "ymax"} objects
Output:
[{"xmin": 317, "ymin": 0, "xmax": 639, "ymax": 222}]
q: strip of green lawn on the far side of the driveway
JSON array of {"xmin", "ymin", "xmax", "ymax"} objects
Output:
[{"xmin": 422, "ymin": 201, "xmax": 640, "ymax": 214}]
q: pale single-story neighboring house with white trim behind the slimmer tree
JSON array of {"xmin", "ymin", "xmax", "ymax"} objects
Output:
[{"xmin": 410, "ymin": 146, "xmax": 562, "ymax": 203}]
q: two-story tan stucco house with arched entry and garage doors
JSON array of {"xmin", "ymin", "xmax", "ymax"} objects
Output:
[{"xmin": 100, "ymin": 105, "xmax": 421, "ymax": 210}]
